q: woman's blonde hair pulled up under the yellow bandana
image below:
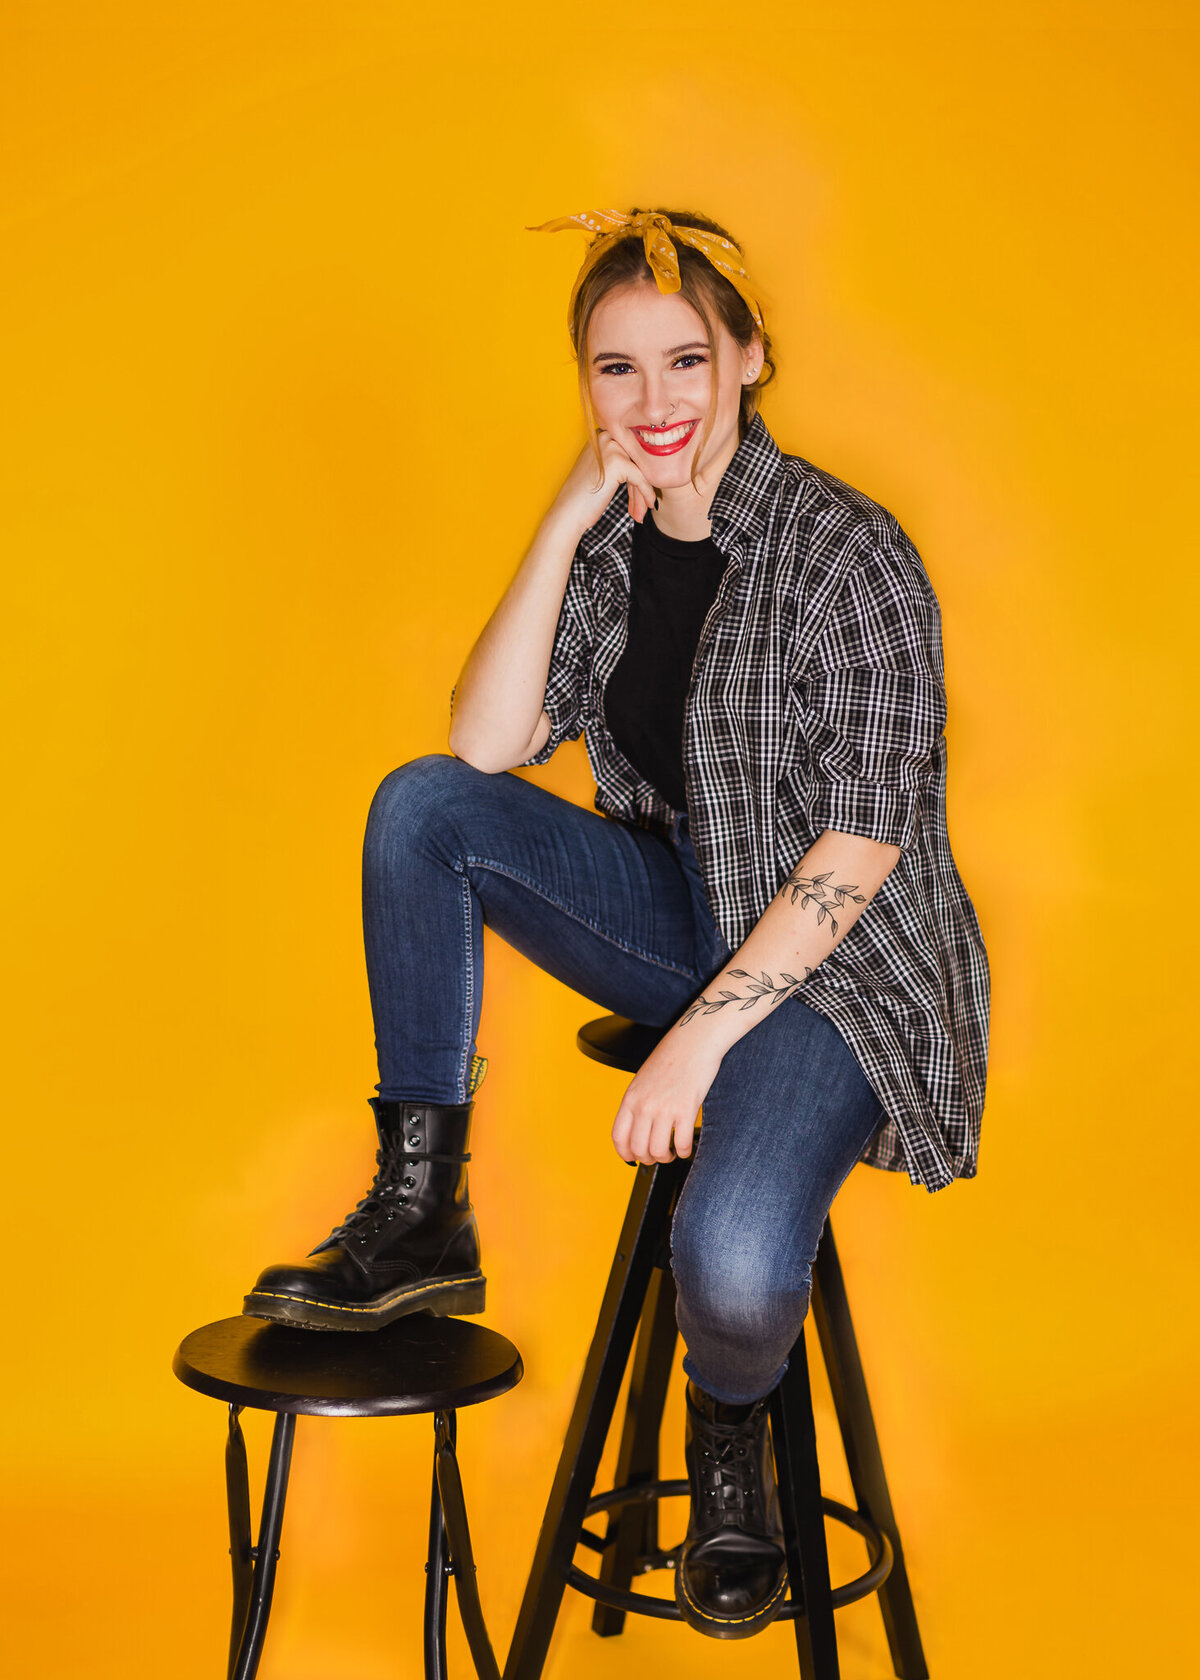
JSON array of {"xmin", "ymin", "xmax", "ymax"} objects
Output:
[{"xmin": 570, "ymin": 210, "xmax": 775, "ymax": 489}]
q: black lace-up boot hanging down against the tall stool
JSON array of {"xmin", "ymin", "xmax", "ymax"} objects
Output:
[{"xmin": 676, "ymin": 1383, "xmax": 788, "ymax": 1640}]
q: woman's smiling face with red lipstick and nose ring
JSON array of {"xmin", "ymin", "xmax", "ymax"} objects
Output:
[{"xmin": 588, "ymin": 281, "xmax": 761, "ymax": 491}]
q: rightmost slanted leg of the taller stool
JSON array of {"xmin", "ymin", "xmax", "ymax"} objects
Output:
[{"xmin": 812, "ymin": 1223, "xmax": 929, "ymax": 1680}]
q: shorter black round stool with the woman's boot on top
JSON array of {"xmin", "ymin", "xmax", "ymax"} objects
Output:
[{"xmin": 173, "ymin": 1312, "xmax": 523, "ymax": 1680}]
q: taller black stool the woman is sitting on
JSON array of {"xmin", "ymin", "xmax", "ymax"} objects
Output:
[{"xmin": 504, "ymin": 1015, "xmax": 928, "ymax": 1680}]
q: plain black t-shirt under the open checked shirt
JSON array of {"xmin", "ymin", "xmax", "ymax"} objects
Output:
[{"xmin": 603, "ymin": 511, "xmax": 726, "ymax": 811}]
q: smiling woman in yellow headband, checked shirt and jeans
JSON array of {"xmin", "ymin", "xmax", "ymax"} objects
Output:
[{"xmin": 245, "ymin": 210, "xmax": 988, "ymax": 1638}]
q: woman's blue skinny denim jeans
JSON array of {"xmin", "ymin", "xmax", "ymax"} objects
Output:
[{"xmin": 363, "ymin": 754, "xmax": 884, "ymax": 1403}]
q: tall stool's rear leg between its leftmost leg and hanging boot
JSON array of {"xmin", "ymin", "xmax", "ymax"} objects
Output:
[{"xmin": 592, "ymin": 1265, "xmax": 679, "ymax": 1640}]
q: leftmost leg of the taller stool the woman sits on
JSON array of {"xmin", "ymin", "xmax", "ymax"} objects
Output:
[{"xmin": 504, "ymin": 1161, "xmax": 687, "ymax": 1680}]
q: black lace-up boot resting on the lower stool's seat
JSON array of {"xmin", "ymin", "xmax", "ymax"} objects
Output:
[{"xmin": 242, "ymin": 1097, "xmax": 486, "ymax": 1331}]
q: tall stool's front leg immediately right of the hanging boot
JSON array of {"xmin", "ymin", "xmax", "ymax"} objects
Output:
[{"xmin": 770, "ymin": 1331, "xmax": 839, "ymax": 1680}]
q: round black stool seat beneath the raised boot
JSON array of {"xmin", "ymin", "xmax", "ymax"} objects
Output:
[{"xmin": 173, "ymin": 1312, "xmax": 523, "ymax": 1418}]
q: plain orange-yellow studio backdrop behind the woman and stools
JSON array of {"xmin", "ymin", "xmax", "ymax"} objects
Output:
[{"xmin": 0, "ymin": 0, "xmax": 1198, "ymax": 1680}]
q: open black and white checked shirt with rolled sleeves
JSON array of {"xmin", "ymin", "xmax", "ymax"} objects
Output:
[{"xmin": 510, "ymin": 415, "xmax": 990, "ymax": 1189}]
